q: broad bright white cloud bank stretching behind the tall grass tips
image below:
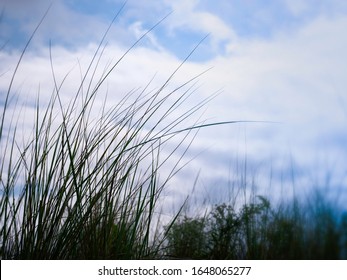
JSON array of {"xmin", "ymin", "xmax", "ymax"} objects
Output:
[{"xmin": 0, "ymin": 1, "xmax": 347, "ymax": 205}]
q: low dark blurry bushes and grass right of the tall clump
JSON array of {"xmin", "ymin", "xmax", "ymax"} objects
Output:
[{"xmin": 166, "ymin": 192, "xmax": 347, "ymax": 260}]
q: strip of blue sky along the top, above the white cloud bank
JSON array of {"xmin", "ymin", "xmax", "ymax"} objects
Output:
[{"xmin": 1, "ymin": 0, "xmax": 347, "ymax": 59}]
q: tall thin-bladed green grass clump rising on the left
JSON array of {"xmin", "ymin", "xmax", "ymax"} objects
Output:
[{"xmin": 0, "ymin": 8, "xmax": 239, "ymax": 259}]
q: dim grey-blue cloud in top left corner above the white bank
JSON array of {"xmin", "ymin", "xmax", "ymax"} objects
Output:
[{"xmin": 0, "ymin": 0, "xmax": 140, "ymax": 49}]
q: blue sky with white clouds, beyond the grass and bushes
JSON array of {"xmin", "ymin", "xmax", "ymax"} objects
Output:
[{"xmin": 0, "ymin": 0, "xmax": 347, "ymax": 210}]
